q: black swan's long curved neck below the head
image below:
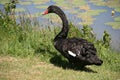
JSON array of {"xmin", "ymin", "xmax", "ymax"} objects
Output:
[{"xmin": 54, "ymin": 12, "xmax": 69, "ymax": 41}]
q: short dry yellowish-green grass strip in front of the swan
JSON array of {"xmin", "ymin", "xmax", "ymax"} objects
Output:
[{"xmin": 0, "ymin": 56, "xmax": 120, "ymax": 80}]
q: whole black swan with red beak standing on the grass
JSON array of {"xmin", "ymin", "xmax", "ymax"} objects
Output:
[{"xmin": 43, "ymin": 5, "xmax": 103, "ymax": 67}]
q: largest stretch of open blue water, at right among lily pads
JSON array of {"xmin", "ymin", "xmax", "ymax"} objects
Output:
[{"xmin": 88, "ymin": 0, "xmax": 120, "ymax": 50}]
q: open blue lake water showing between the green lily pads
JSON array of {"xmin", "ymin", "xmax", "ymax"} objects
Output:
[{"xmin": 0, "ymin": 0, "xmax": 120, "ymax": 50}]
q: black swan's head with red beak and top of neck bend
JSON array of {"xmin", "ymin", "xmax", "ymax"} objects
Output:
[{"xmin": 43, "ymin": 5, "xmax": 63, "ymax": 15}]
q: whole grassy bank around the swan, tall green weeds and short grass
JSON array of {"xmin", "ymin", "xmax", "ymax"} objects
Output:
[{"xmin": 0, "ymin": 9, "xmax": 120, "ymax": 80}]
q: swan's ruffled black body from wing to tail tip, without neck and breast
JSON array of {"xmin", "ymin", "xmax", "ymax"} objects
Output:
[{"xmin": 62, "ymin": 38, "xmax": 102, "ymax": 65}]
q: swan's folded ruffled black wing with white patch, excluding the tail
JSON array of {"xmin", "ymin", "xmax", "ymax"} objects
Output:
[{"xmin": 63, "ymin": 38, "xmax": 96, "ymax": 57}]
